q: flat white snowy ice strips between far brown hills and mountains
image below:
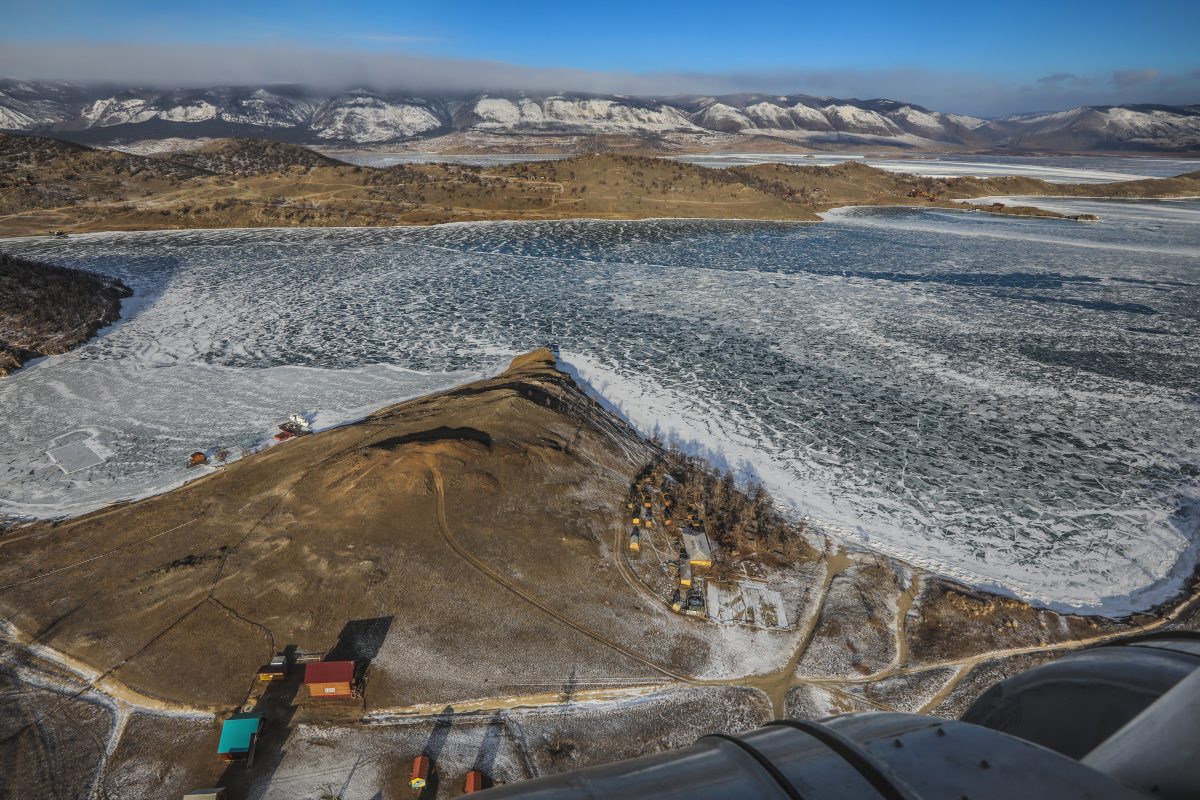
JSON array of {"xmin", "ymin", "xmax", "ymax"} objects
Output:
[{"xmin": 332, "ymin": 152, "xmax": 1200, "ymax": 184}]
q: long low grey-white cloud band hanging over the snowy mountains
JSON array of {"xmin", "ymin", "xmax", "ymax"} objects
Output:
[{"xmin": 0, "ymin": 35, "xmax": 1200, "ymax": 116}]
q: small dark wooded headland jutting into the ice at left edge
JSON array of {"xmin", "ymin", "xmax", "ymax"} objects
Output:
[{"xmin": 0, "ymin": 253, "xmax": 133, "ymax": 377}]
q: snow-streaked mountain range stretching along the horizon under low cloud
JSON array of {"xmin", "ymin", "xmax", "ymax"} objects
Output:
[{"xmin": 0, "ymin": 79, "xmax": 1200, "ymax": 151}]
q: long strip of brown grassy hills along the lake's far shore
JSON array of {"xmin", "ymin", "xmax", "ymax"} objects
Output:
[{"xmin": 0, "ymin": 134, "xmax": 1200, "ymax": 235}]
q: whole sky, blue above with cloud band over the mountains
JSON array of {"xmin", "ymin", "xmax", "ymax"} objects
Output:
[{"xmin": 0, "ymin": 0, "xmax": 1200, "ymax": 116}]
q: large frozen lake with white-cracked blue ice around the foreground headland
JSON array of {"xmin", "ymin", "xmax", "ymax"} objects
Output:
[{"xmin": 0, "ymin": 199, "xmax": 1200, "ymax": 613}]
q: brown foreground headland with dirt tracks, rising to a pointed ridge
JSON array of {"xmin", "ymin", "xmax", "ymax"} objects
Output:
[{"xmin": 0, "ymin": 350, "xmax": 1196, "ymax": 798}]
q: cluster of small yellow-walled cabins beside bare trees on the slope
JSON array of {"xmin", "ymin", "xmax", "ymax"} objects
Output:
[{"xmin": 626, "ymin": 473, "xmax": 713, "ymax": 616}]
